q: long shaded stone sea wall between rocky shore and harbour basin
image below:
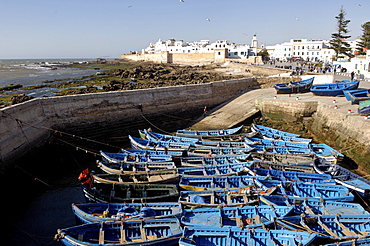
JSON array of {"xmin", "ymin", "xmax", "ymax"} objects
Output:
[{"xmin": 0, "ymin": 78, "xmax": 257, "ymax": 169}]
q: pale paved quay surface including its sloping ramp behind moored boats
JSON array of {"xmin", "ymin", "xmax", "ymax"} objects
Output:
[{"xmin": 191, "ymin": 75, "xmax": 370, "ymax": 130}]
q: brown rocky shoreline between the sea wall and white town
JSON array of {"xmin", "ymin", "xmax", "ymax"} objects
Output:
[{"xmin": 0, "ymin": 59, "xmax": 294, "ymax": 106}]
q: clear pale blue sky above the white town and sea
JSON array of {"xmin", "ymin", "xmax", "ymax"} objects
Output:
[{"xmin": 0, "ymin": 0, "xmax": 370, "ymax": 59}]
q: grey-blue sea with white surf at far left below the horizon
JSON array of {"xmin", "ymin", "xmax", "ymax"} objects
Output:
[{"xmin": 0, "ymin": 59, "xmax": 96, "ymax": 87}]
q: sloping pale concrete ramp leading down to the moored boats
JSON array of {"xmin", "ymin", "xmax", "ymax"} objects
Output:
[{"xmin": 191, "ymin": 88, "xmax": 276, "ymax": 130}]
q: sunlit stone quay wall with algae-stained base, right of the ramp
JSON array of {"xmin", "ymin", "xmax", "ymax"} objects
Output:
[{"xmin": 256, "ymin": 96, "xmax": 370, "ymax": 172}]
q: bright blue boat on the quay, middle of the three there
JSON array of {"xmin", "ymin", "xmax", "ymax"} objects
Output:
[{"xmin": 311, "ymin": 80, "xmax": 360, "ymax": 96}]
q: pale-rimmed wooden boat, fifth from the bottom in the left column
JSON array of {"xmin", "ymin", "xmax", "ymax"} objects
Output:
[{"xmin": 97, "ymin": 161, "xmax": 176, "ymax": 174}]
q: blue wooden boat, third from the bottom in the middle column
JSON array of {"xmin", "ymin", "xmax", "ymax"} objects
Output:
[{"xmin": 179, "ymin": 189, "xmax": 268, "ymax": 208}]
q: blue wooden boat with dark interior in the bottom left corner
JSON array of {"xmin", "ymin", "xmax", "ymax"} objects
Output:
[{"xmin": 55, "ymin": 218, "xmax": 182, "ymax": 246}]
